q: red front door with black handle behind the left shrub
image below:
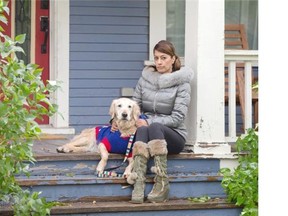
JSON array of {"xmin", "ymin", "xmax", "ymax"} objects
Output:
[{"xmin": 5, "ymin": 0, "xmax": 49, "ymax": 124}]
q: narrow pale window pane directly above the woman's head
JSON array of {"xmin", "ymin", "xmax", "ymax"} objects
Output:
[{"xmin": 166, "ymin": 0, "xmax": 185, "ymax": 57}]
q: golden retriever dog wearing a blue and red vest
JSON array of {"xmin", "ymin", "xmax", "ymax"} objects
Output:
[{"xmin": 56, "ymin": 98, "xmax": 140, "ymax": 177}]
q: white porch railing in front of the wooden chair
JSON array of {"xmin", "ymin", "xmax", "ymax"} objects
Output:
[{"xmin": 225, "ymin": 50, "xmax": 258, "ymax": 142}]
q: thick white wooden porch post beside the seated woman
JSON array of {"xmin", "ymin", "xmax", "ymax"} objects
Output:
[{"xmin": 185, "ymin": 0, "xmax": 231, "ymax": 154}]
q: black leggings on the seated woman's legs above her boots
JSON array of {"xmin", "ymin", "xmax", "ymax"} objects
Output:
[{"xmin": 135, "ymin": 123, "xmax": 185, "ymax": 154}]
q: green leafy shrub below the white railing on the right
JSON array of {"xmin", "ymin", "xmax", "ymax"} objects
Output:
[{"xmin": 221, "ymin": 129, "xmax": 258, "ymax": 216}]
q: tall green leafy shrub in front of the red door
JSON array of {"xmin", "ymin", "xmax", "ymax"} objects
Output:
[{"xmin": 0, "ymin": 0, "xmax": 58, "ymax": 216}]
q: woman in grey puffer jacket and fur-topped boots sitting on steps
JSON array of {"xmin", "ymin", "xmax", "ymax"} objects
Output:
[{"xmin": 127, "ymin": 40, "xmax": 194, "ymax": 203}]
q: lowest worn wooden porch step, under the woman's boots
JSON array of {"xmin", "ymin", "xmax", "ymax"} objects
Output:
[{"xmin": 0, "ymin": 198, "xmax": 241, "ymax": 216}]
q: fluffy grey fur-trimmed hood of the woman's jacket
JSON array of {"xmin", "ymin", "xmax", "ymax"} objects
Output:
[{"xmin": 142, "ymin": 66, "xmax": 194, "ymax": 88}]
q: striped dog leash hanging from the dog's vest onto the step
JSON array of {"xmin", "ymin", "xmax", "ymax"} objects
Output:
[{"xmin": 96, "ymin": 134, "xmax": 135, "ymax": 178}]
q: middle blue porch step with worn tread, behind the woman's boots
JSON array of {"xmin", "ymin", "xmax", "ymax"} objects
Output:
[{"xmin": 17, "ymin": 173, "xmax": 226, "ymax": 201}]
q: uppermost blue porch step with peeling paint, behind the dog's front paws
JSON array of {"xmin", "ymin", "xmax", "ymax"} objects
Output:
[{"xmin": 24, "ymin": 153, "xmax": 220, "ymax": 176}]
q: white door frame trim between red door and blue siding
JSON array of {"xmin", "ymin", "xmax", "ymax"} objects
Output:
[{"xmin": 41, "ymin": 0, "xmax": 75, "ymax": 134}]
